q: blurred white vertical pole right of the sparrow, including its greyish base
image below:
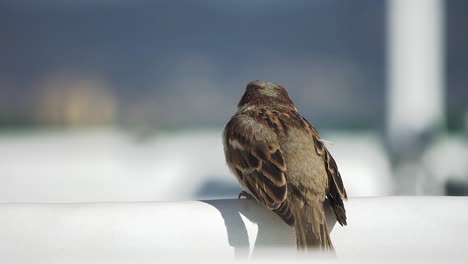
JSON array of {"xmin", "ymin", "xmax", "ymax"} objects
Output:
[{"xmin": 386, "ymin": 0, "xmax": 445, "ymax": 194}]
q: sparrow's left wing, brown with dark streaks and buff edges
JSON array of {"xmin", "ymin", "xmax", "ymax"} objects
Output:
[{"xmin": 225, "ymin": 116, "xmax": 289, "ymax": 213}]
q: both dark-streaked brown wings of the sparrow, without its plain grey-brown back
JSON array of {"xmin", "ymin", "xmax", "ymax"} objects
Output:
[{"xmin": 224, "ymin": 108, "xmax": 347, "ymax": 225}]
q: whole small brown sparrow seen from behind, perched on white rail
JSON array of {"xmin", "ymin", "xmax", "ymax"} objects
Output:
[{"xmin": 223, "ymin": 81, "xmax": 347, "ymax": 251}]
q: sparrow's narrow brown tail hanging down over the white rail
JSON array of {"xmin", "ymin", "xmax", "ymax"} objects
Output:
[{"xmin": 294, "ymin": 203, "xmax": 334, "ymax": 251}]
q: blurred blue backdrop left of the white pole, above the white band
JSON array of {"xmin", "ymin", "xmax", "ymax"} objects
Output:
[{"xmin": 0, "ymin": 0, "xmax": 385, "ymax": 128}]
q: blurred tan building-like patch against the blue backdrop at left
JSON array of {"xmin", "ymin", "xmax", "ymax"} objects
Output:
[{"xmin": 35, "ymin": 72, "xmax": 118, "ymax": 127}]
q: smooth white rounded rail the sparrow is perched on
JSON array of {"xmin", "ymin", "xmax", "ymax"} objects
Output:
[{"xmin": 0, "ymin": 197, "xmax": 468, "ymax": 263}]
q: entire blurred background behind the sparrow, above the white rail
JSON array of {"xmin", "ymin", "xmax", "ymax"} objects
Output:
[{"xmin": 0, "ymin": 0, "xmax": 468, "ymax": 202}]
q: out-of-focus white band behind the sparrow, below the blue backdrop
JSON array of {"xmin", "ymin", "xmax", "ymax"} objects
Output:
[{"xmin": 0, "ymin": 128, "xmax": 394, "ymax": 203}]
